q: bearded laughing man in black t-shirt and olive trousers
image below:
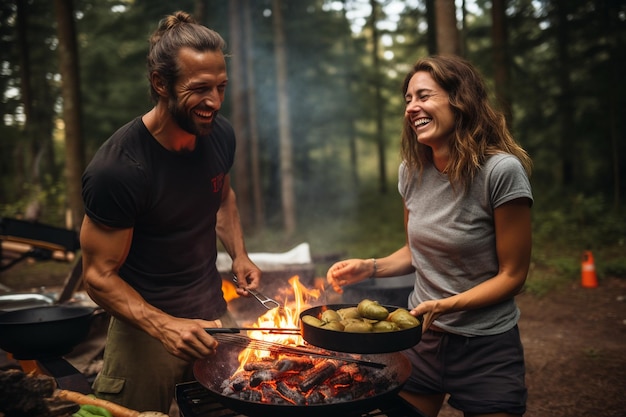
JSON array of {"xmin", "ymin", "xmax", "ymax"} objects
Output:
[{"xmin": 80, "ymin": 12, "xmax": 261, "ymax": 413}]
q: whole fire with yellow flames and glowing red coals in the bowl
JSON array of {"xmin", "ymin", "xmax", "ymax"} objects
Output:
[{"xmin": 220, "ymin": 276, "xmax": 397, "ymax": 406}]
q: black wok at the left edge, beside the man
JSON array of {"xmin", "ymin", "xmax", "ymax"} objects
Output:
[{"xmin": 0, "ymin": 305, "xmax": 102, "ymax": 360}]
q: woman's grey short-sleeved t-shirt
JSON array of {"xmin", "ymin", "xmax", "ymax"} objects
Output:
[{"xmin": 398, "ymin": 153, "xmax": 533, "ymax": 336}]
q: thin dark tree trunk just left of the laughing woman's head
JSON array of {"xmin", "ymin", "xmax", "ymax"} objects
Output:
[{"xmin": 370, "ymin": 0, "xmax": 387, "ymax": 194}]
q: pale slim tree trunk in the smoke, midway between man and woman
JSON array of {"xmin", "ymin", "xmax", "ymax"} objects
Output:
[{"xmin": 272, "ymin": 0, "xmax": 296, "ymax": 238}]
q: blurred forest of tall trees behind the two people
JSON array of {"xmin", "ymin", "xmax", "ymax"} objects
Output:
[{"xmin": 0, "ymin": 0, "xmax": 626, "ymax": 293}]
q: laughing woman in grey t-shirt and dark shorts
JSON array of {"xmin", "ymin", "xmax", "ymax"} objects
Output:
[{"xmin": 327, "ymin": 56, "xmax": 533, "ymax": 417}]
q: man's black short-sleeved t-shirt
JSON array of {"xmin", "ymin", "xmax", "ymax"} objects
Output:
[{"xmin": 82, "ymin": 116, "xmax": 235, "ymax": 320}]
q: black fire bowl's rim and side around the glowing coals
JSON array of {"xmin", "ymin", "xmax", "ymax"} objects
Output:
[{"xmin": 193, "ymin": 343, "xmax": 411, "ymax": 417}]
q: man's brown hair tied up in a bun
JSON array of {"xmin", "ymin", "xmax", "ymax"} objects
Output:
[{"xmin": 147, "ymin": 11, "xmax": 226, "ymax": 102}]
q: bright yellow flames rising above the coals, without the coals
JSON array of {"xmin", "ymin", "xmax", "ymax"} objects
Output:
[{"xmin": 239, "ymin": 275, "xmax": 322, "ymax": 369}]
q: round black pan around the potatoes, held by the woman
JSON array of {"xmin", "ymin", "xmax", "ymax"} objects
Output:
[{"xmin": 300, "ymin": 304, "xmax": 422, "ymax": 353}]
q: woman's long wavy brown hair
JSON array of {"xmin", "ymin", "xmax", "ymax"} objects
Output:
[{"xmin": 400, "ymin": 55, "xmax": 532, "ymax": 189}]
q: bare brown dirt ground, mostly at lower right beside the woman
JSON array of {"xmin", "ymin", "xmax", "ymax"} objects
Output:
[{"xmin": 0, "ymin": 262, "xmax": 626, "ymax": 417}]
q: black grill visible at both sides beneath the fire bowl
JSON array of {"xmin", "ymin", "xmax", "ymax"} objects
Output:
[{"xmin": 176, "ymin": 381, "xmax": 425, "ymax": 417}]
